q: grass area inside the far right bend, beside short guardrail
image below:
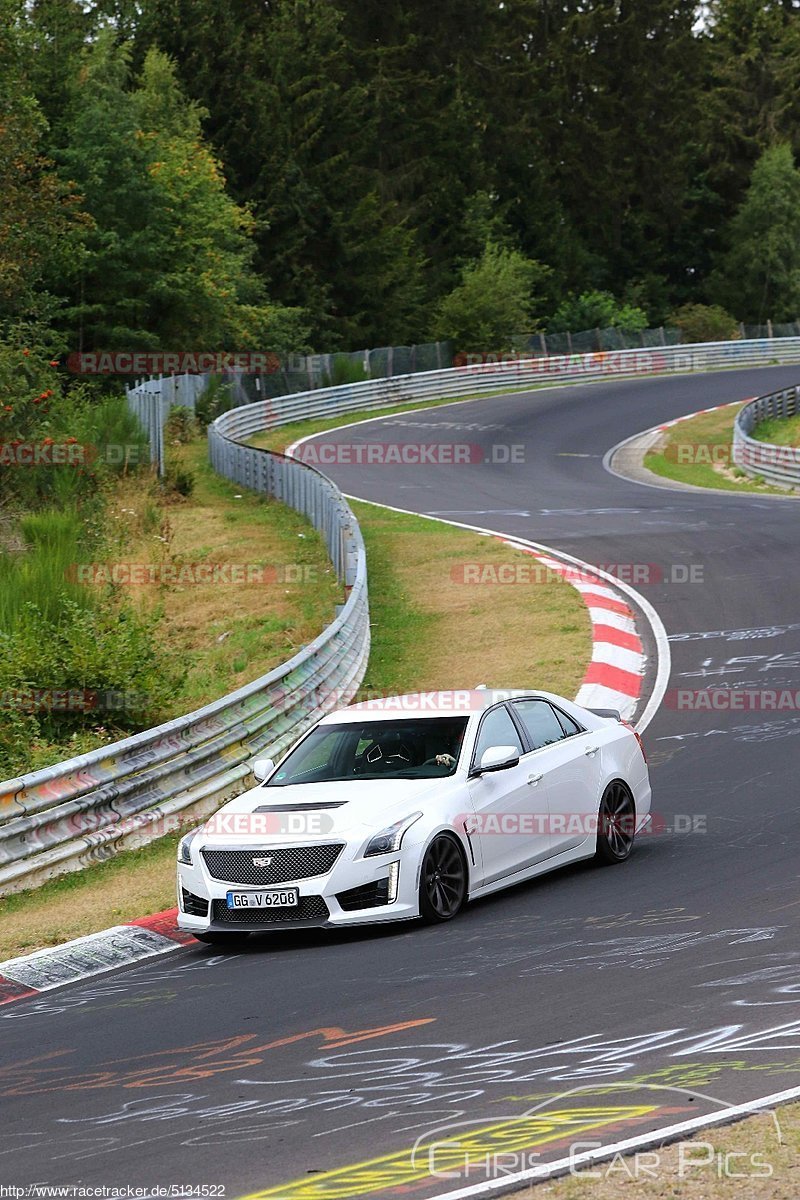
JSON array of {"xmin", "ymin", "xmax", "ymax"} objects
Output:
[{"xmin": 644, "ymin": 406, "xmax": 793, "ymax": 496}]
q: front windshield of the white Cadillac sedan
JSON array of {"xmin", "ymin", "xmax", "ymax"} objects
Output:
[{"xmin": 264, "ymin": 716, "xmax": 468, "ymax": 787}]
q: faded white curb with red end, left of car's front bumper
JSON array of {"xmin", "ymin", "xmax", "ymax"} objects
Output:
[{"xmin": 0, "ymin": 908, "xmax": 194, "ymax": 1006}]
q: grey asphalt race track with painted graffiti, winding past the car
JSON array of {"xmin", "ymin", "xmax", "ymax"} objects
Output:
[{"xmin": 0, "ymin": 367, "xmax": 800, "ymax": 1200}]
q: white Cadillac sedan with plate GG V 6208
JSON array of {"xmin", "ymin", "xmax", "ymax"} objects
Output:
[{"xmin": 178, "ymin": 689, "xmax": 650, "ymax": 943}]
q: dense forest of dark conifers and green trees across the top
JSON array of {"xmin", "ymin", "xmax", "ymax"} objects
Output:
[{"xmin": 0, "ymin": 0, "xmax": 800, "ymax": 355}]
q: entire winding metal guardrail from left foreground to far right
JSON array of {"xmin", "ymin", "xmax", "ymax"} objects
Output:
[{"xmin": 0, "ymin": 337, "xmax": 800, "ymax": 893}]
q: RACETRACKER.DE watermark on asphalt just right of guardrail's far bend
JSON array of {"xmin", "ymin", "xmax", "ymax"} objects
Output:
[{"xmin": 294, "ymin": 439, "xmax": 525, "ymax": 467}]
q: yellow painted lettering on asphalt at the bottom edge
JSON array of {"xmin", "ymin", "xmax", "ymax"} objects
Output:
[{"xmin": 243, "ymin": 1104, "xmax": 658, "ymax": 1200}]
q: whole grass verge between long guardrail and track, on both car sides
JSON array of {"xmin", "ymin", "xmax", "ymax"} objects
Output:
[{"xmin": 0, "ymin": 503, "xmax": 591, "ymax": 959}]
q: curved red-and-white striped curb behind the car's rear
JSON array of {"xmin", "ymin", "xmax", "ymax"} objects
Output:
[{"xmin": 501, "ymin": 538, "xmax": 646, "ymax": 721}]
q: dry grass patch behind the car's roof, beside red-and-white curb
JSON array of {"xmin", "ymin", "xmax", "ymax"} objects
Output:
[{"xmin": 353, "ymin": 502, "xmax": 591, "ymax": 695}]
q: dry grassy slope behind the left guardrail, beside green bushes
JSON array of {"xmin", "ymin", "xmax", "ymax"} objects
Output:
[{"xmin": 108, "ymin": 437, "xmax": 343, "ymax": 718}]
